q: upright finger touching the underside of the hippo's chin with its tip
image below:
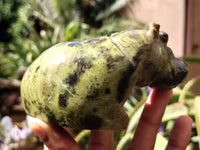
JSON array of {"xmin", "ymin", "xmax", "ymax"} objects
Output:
[{"xmin": 129, "ymin": 89, "xmax": 172, "ymax": 150}]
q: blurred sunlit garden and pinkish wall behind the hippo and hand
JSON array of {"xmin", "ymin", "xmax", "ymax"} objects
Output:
[{"xmin": 0, "ymin": 0, "xmax": 200, "ymax": 150}]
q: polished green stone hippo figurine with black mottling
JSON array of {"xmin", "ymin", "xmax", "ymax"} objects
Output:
[{"xmin": 21, "ymin": 23, "xmax": 187, "ymax": 131}]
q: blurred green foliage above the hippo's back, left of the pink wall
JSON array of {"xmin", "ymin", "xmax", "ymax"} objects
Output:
[{"xmin": 0, "ymin": 0, "xmax": 144, "ymax": 77}]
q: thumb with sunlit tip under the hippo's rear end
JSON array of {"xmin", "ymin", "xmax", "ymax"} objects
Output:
[{"xmin": 28, "ymin": 118, "xmax": 80, "ymax": 150}]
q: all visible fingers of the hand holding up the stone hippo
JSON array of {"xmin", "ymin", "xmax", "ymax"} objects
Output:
[{"xmin": 29, "ymin": 89, "xmax": 192, "ymax": 150}]
